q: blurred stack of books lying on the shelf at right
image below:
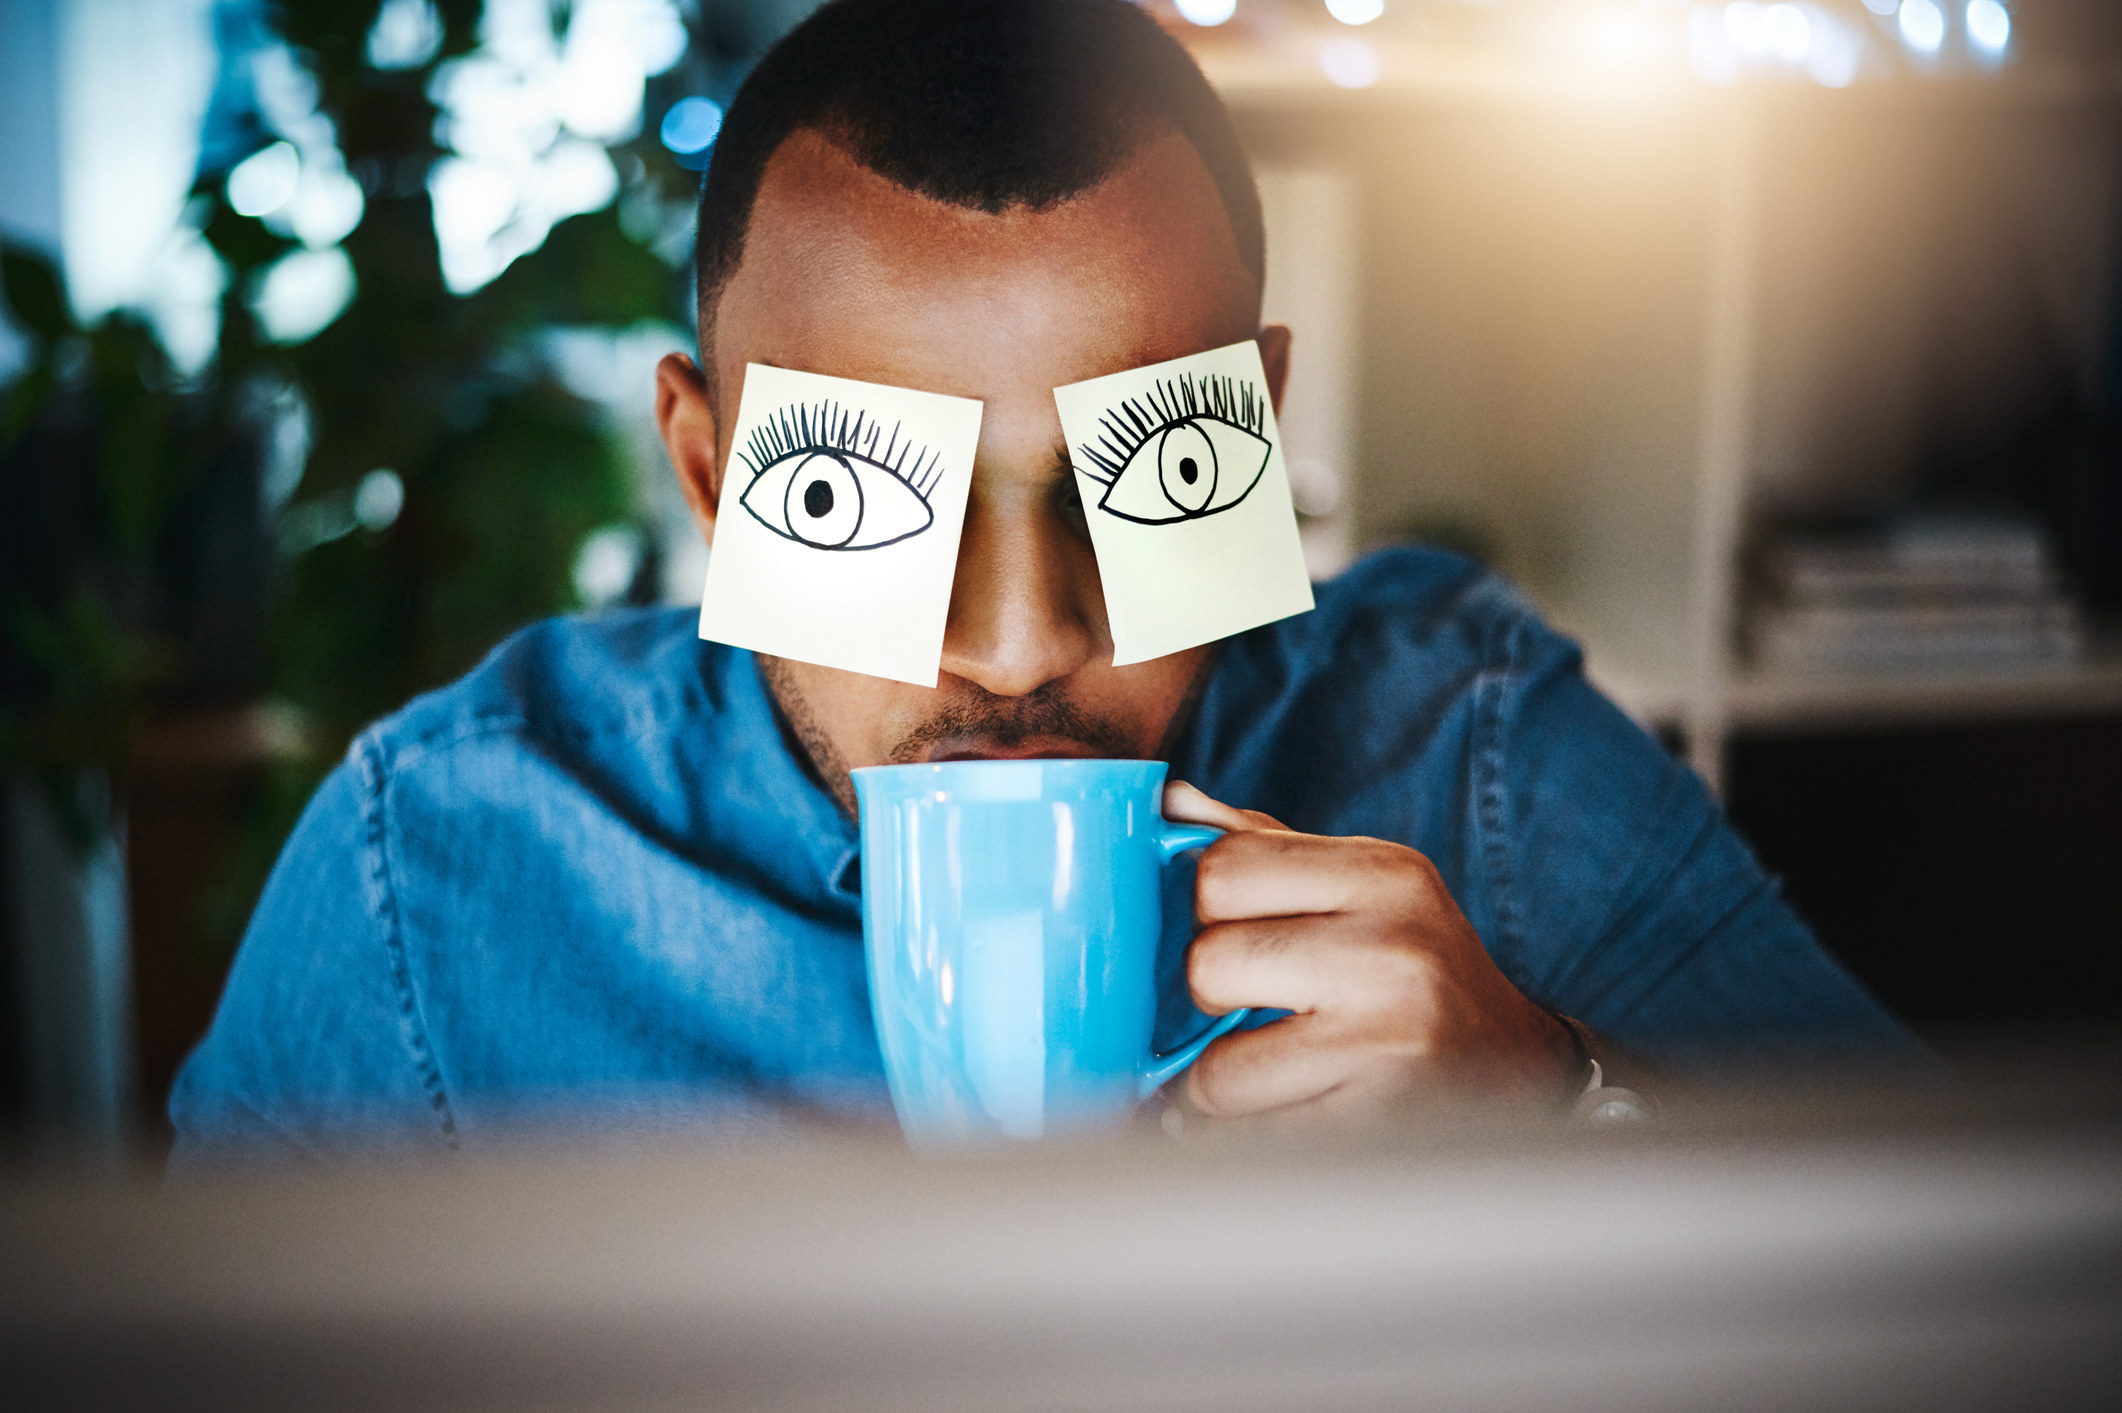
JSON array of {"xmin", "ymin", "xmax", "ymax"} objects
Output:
[{"xmin": 1749, "ymin": 516, "xmax": 2084, "ymax": 673}]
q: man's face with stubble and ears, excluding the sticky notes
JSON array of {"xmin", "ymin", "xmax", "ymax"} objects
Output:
[{"xmin": 656, "ymin": 132, "xmax": 1288, "ymax": 806}]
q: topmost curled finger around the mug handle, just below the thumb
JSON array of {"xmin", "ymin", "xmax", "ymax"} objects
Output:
[{"xmin": 1195, "ymin": 830, "xmax": 1441, "ymax": 923}]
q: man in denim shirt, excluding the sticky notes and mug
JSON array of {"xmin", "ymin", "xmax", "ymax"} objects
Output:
[{"xmin": 172, "ymin": 0, "xmax": 1910, "ymax": 1146}]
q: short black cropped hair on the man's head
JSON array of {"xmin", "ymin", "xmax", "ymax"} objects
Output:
[{"xmin": 694, "ymin": 0, "xmax": 1267, "ymax": 354}]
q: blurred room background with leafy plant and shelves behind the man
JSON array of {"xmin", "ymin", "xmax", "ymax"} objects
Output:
[{"xmin": 0, "ymin": 0, "xmax": 2122, "ymax": 1144}]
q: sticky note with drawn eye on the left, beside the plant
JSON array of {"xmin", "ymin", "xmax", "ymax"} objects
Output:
[{"xmin": 700, "ymin": 363, "xmax": 980, "ymax": 687}]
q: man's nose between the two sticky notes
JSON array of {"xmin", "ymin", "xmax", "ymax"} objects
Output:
[{"xmin": 942, "ymin": 482, "xmax": 1106, "ymax": 696}]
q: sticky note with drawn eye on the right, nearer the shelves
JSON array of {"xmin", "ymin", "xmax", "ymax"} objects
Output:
[{"xmin": 1055, "ymin": 339, "xmax": 1311, "ymax": 666}]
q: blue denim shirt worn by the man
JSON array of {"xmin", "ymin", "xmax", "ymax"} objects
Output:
[{"xmin": 170, "ymin": 550, "xmax": 1912, "ymax": 1152}]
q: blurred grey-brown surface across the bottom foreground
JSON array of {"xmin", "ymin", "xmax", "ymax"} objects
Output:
[{"xmin": 0, "ymin": 1052, "xmax": 2122, "ymax": 1413}]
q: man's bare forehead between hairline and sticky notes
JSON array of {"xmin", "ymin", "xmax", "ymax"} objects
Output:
[{"xmin": 713, "ymin": 129, "xmax": 1258, "ymax": 401}]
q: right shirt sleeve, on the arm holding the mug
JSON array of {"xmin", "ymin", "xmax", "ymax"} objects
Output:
[{"xmin": 1477, "ymin": 615, "xmax": 1929, "ymax": 1071}]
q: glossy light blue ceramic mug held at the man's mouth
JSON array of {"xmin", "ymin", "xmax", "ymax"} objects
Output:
[{"xmin": 853, "ymin": 760, "xmax": 1250, "ymax": 1146}]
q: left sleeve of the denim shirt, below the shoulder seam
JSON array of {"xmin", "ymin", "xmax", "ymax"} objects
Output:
[{"xmin": 170, "ymin": 743, "xmax": 450, "ymax": 1167}]
